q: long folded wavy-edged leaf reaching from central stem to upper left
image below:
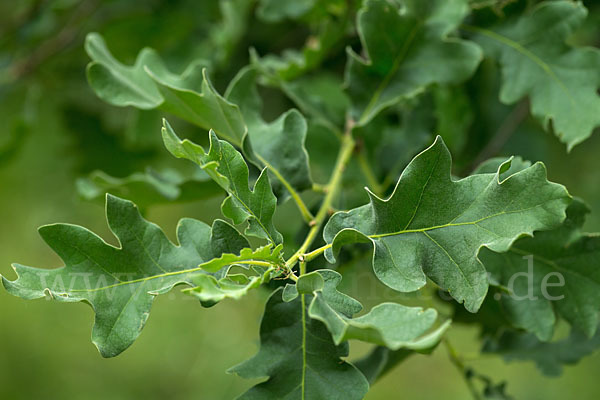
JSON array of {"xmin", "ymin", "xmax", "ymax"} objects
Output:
[{"xmin": 86, "ymin": 34, "xmax": 312, "ymax": 203}]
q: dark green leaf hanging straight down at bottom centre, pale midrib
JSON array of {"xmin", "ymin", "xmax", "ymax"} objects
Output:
[{"xmin": 229, "ymin": 290, "xmax": 369, "ymax": 400}]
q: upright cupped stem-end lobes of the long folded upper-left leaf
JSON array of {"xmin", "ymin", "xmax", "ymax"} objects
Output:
[{"xmin": 225, "ymin": 67, "xmax": 312, "ymax": 198}]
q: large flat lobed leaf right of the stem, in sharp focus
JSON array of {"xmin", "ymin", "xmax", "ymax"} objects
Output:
[{"xmin": 323, "ymin": 137, "xmax": 570, "ymax": 312}]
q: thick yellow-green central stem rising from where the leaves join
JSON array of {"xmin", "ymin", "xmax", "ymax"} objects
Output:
[{"xmin": 285, "ymin": 123, "xmax": 354, "ymax": 275}]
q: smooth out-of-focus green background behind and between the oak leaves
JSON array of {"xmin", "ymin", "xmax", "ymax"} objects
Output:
[{"xmin": 0, "ymin": 1, "xmax": 600, "ymax": 400}]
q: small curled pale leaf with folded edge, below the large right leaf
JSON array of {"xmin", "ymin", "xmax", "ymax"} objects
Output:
[{"xmin": 288, "ymin": 270, "xmax": 450, "ymax": 350}]
